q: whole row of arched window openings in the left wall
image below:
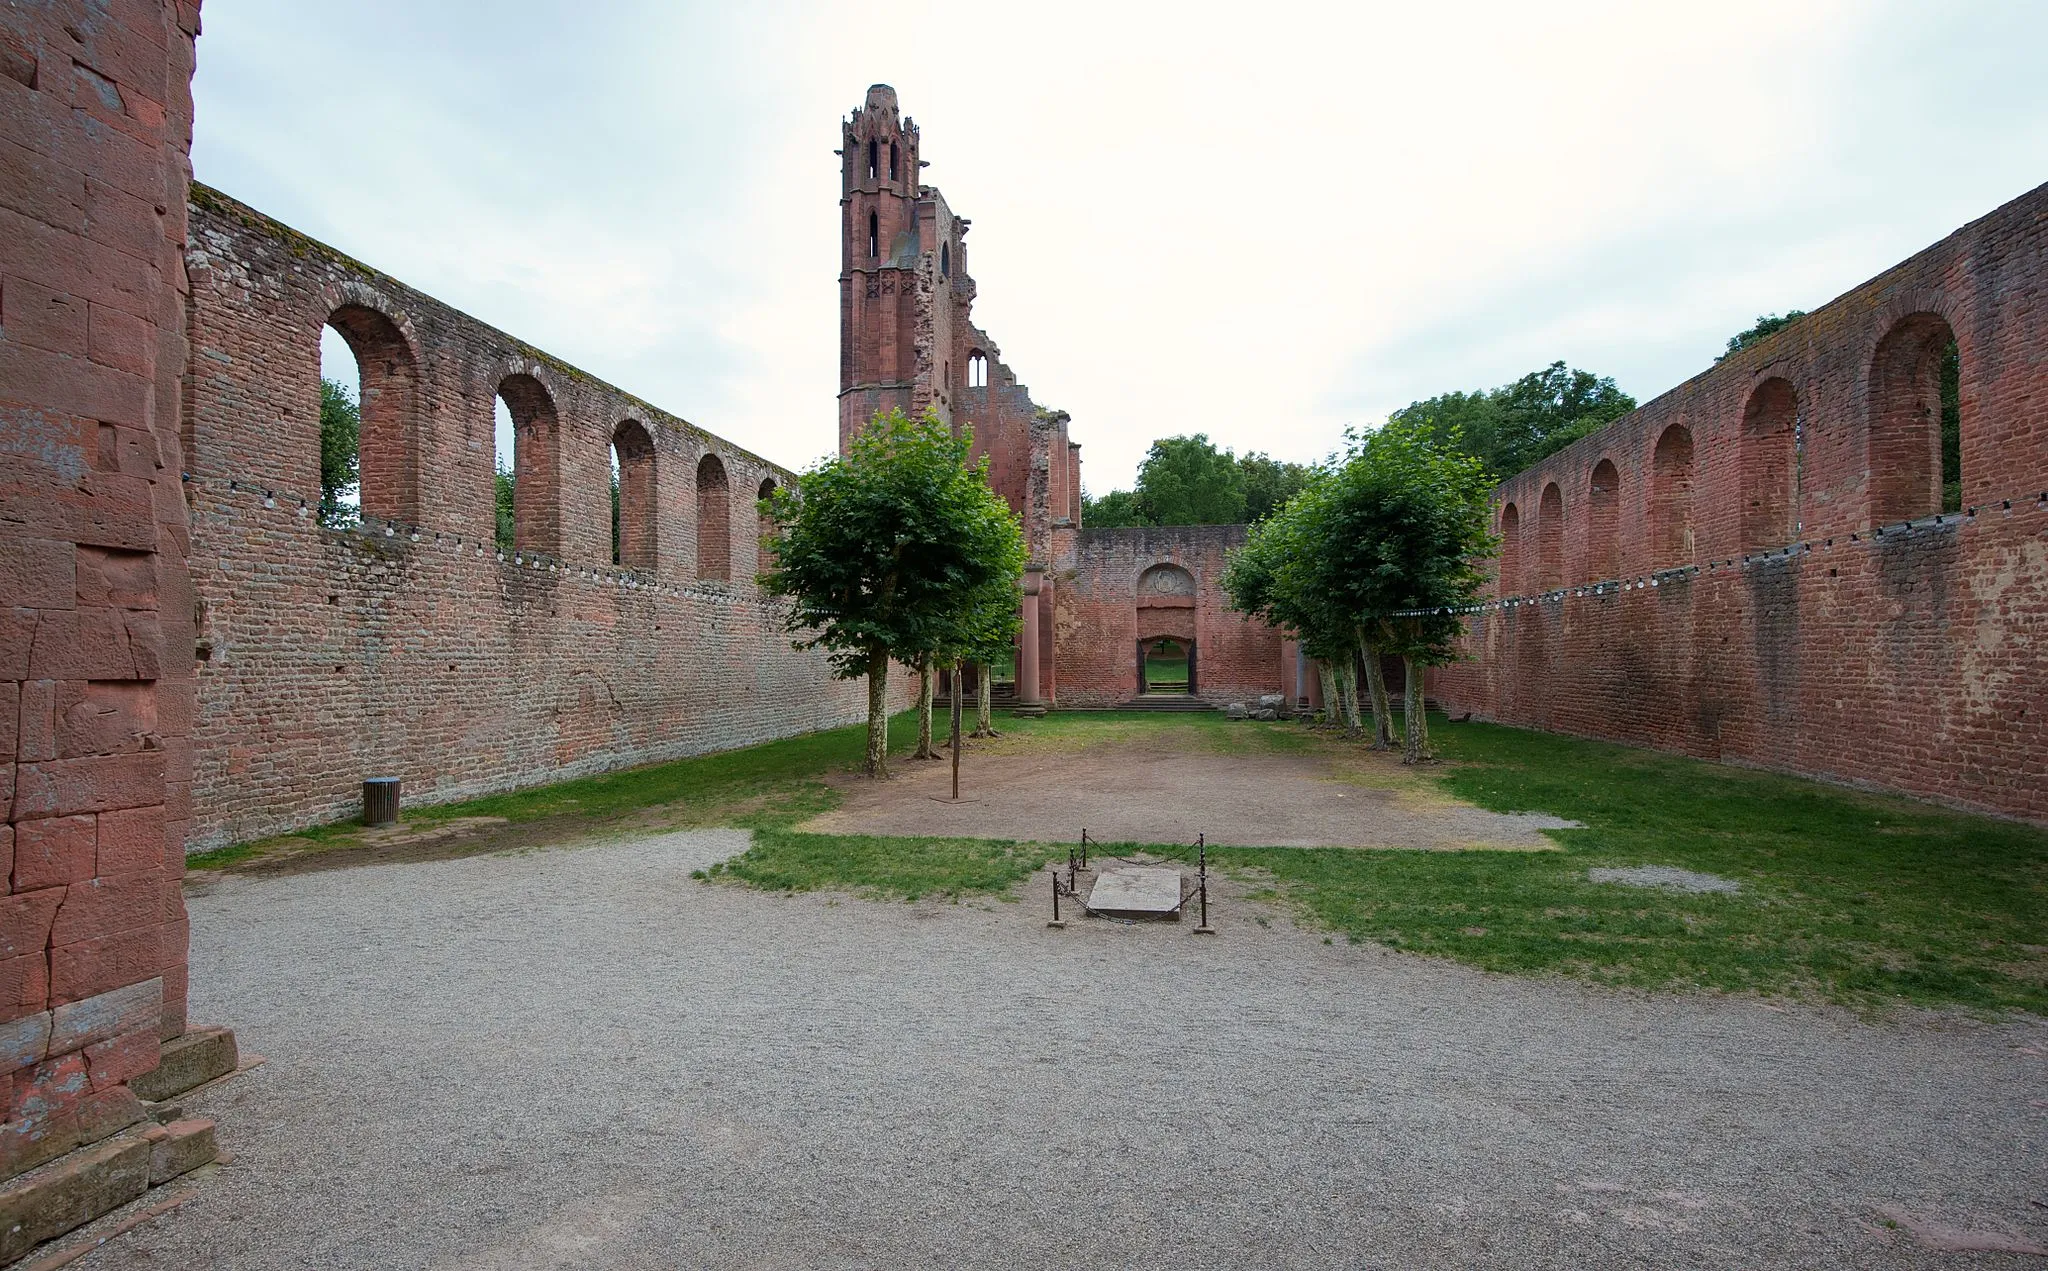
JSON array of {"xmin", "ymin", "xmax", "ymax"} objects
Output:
[{"xmin": 319, "ymin": 305, "xmax": 776, "ymax": 581}]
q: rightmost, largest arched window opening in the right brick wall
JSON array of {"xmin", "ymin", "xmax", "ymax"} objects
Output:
[{"xmin": 1870, "ymin": 313, "xmax": 1962, "ymax": 524}]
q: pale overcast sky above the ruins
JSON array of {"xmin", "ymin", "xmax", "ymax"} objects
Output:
[{"xmin": 193, "ymin": 0, "xmax": 2048, "ymax": 493}]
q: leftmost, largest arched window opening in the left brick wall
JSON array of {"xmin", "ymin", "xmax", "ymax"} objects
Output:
[{"xmin": 319, "ymin": 305, "xmax": 420, "ymax": 524}]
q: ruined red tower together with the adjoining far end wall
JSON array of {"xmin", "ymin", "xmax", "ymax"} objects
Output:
[{"xmin": 840, "ymin": 84, "xmax": 1292, "ymax": 706}]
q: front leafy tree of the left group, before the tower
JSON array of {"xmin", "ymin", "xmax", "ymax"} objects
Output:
[{"xmin": 762, "ymin": 411, "xmax": 1024, "ymax": 778}]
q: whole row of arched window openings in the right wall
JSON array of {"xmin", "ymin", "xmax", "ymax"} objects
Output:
[{"xmin": 1499, "ymin": 313, "xmax": 1962, "ymax": 594}]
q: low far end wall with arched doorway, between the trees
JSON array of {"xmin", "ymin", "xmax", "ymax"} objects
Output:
[{"xmin": 1055, "ymin": 526, "xmax": 1280, "ymax": 706}]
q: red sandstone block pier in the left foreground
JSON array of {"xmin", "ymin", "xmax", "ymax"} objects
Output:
[{"xmin": 0, "ymin": 0, "xmax": 199, "ymax": 1177}]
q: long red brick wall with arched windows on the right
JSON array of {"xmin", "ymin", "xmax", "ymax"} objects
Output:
[{"xmin": 1434, "ymin": 186, "xmax": 2048, "ymax": 821}]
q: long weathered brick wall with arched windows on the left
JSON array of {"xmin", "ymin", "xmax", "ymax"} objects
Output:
[{"xmin": 186, "ymin": 186, "xmax": 888, "ymax": 847}]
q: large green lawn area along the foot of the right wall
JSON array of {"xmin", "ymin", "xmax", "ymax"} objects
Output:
[{"xmin": 1219, "ymin": 725, "xmax": 2048, "ymax": 1013}]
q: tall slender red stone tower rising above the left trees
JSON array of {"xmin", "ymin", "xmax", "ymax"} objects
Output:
[{"xmin": 840, "ymin": 84, "xmax": 930, "ymax": 452}]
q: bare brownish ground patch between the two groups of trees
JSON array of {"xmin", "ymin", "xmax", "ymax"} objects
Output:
[{"xmin": 801, "ymin": 731, "xmax": 1579, "ymax": 851}]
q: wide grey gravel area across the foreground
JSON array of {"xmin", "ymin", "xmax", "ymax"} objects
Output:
[{"xmin": 68, "ymin": 831, "xmax": 2048, "ymax": 1269}]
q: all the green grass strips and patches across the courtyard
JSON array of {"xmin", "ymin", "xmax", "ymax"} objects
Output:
[{"xmin": 190, "ymin": 712, "xmax": 2048, "ymax": 1015}]
